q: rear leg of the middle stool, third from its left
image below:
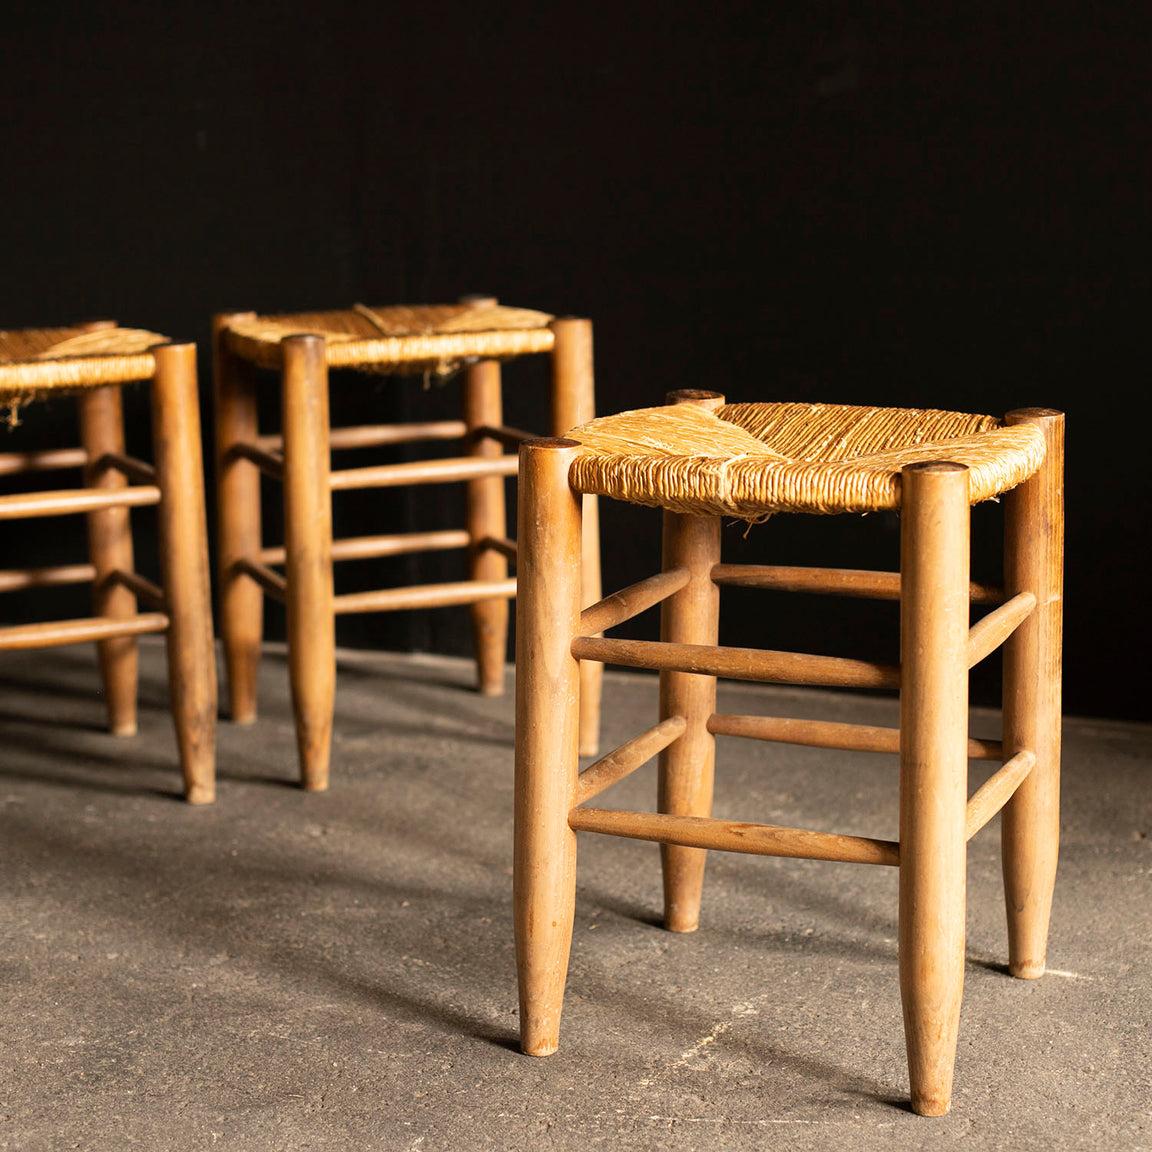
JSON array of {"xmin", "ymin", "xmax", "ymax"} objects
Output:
[{"xmin": 464, "ymin": 361, "xmax": 508, "ymax": 696}]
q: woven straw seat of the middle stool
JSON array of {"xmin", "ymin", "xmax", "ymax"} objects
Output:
[{"xmin": 226, "ymin": 303, "xmax": 553, "ymax": 376}]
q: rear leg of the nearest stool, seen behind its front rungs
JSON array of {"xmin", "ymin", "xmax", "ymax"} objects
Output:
[{"xmin": 659, "ymin": 511, "xmax": 720, "ymax": 932}]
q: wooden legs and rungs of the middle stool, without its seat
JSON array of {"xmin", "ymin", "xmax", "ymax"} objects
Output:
[{"xmin": 214, "ymin": 306, "xmax": 602, "ymax": 791}]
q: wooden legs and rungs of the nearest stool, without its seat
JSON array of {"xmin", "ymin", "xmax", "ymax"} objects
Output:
[{"xmin": 514, "ymin": 392, "xmax": 1064, "ymax": 1116}]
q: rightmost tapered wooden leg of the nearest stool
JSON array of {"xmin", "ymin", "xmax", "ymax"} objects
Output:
[{"xmin": 1000, "ymin": 408, "xmax": 1064, "ymax": 979}]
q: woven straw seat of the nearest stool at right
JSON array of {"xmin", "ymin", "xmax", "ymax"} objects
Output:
[{"xmin": 569, "ymin": 403, "xmax": 1045, "ymax": 520}]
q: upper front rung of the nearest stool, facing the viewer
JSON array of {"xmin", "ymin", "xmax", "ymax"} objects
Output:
[{"xmin": 573, "ymin": 636, "xmax": 900, "ymax": 688}]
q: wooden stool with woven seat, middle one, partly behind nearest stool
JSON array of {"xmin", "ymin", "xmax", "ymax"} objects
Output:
[{"xmin": 215, "ymin": 297, "xmax": 601, "ymax": 790}]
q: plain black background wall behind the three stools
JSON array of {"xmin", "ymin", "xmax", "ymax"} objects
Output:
[{"xmin": 0, "ymin": 2, "xmax": 1152, "ymax": 719}]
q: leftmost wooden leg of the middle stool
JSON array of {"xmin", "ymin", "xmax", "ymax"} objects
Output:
[{"xmin": 213, "ymin": 312, "xmax": 264, "ymax": 723}]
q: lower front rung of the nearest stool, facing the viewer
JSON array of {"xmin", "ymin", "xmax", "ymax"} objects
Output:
[{"xmin": 568, "ymin": 808, "xmax": 900, "ymax": 866}]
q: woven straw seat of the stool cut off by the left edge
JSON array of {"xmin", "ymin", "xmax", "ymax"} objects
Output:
[{"xmin": 0, "ymin": 325, "xmax": 169, "ymax": 406}]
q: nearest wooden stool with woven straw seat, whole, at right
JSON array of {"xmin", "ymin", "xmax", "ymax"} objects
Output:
[{"xmin": 515, "ymin": 393, "xmax": 1063, "ymax": 1115}]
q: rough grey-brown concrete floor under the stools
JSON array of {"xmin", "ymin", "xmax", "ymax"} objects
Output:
[{"xmin": 0, "ymin": 644, "xmax": 1152, "ymax": 1152}]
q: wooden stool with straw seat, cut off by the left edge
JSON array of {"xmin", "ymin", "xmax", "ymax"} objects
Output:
[{"xmin": 0, "ymin": 321, "xmax": 217, "ymax": 804}]
